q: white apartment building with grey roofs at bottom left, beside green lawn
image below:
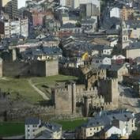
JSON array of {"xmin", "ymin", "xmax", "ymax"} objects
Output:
[{"xmin": 25, "ymin": 118, "xmax": 62, "ymax": 139}]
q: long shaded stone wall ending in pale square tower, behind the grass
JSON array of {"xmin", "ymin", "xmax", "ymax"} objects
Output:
[{"xmin": 0, "ymin": 61, "xmax": 58, "ymax": 77}]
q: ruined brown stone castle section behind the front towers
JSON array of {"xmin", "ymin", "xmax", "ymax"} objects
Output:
[{"xmin": 59, "ymin": 65, "xmax": 107, "ymax": 89}]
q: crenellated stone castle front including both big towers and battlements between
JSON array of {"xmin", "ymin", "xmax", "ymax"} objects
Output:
[{"xmin": 52, "ymin": 78, "xmax": 119, "ymax": 117}]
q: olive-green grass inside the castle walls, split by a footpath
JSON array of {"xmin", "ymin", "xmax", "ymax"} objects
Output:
[{"xmin": 0, "ymin": 75, "xmax": 76, "ymax": 103}]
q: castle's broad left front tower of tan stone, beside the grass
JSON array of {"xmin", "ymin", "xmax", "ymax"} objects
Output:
[{"xmin": 52, "ymin": 82, "xmax": 76, "ymax": 115}]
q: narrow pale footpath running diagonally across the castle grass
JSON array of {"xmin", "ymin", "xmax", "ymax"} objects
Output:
[{"xmin": 28, "ymin": 79, "xmax": 49, "ymax": 100}]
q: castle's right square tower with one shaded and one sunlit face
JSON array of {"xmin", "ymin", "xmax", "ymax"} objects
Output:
[{"xmin": 99, "ymin": 79, "xmax": 119, "ymax": 106}]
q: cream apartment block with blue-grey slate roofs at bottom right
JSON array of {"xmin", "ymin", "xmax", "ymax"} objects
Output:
[{"xmin": 76, "ymin": 110, "xmax": 136, "ymax": 139}]
